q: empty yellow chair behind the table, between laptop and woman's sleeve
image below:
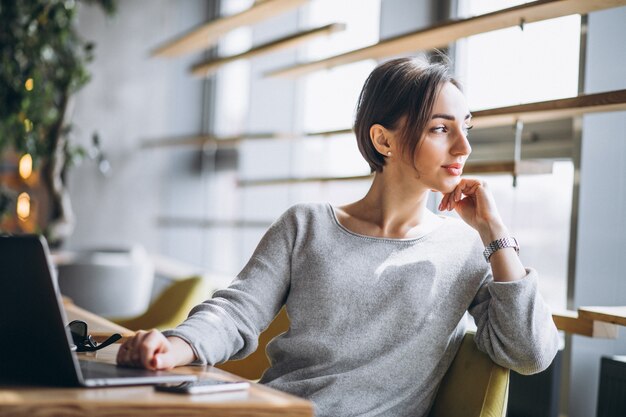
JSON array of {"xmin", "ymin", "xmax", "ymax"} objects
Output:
[{"xmin": 111, "ymin": 277, "xmax": 208, "ymax": 330}]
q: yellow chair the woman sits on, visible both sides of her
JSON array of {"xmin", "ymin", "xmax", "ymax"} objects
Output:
[{"xmin": 217, "ymin": 308, "xmax": 509, "ymax": 417}]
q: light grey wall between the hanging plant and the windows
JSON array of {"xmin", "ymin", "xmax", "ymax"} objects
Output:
[{"xmin": 66, "ymin": 0, "xmax": 207, "ymax": 251}]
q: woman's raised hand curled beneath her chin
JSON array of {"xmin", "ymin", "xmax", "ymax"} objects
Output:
[{"xmin": 439, "ymin": 178, "xmax": 508, "ymax": 244}]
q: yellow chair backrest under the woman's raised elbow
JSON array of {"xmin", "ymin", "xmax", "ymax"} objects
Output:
[{"xmin": 429, "ymin": 333, "xmax": 509, "ymax": 417}]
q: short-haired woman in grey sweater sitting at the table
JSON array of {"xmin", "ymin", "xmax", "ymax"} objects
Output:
[{"xmin": 117, "ymin": 58, "xmax": 558, "ymax": 416}]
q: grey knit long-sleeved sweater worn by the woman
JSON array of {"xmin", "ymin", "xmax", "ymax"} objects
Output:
[{"xmin": 165, "ymin": 204, "xmax": 558, "ymax": 417}]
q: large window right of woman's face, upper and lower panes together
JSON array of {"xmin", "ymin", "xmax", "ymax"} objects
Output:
[{"xmin": 456, "ymin": 0, "xmax": 580, "ymax": 308}]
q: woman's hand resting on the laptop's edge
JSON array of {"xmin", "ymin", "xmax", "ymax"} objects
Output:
[{"xmin": 117, "ymin": 329, "xmax": 196, "ymax": 370}]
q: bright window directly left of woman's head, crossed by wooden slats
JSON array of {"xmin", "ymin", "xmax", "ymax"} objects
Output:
[{"xmin": 293, "ymin": 0, "xmax": 381, "ymax": 200}]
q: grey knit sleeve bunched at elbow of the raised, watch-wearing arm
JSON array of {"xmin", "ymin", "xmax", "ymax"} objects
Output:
[{"xmin": 469, "ymin": 269, "xmax": 559, "ymax": 375}]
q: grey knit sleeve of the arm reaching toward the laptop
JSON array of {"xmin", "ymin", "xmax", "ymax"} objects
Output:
[{"xmin": 163, "ymin": 209, "xmax": 296, "ymax": 365}]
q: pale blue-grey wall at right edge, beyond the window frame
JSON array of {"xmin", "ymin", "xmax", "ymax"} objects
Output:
[{"xmin": 569, "ymin": 7, "xmax": 626, "ymax": 417}]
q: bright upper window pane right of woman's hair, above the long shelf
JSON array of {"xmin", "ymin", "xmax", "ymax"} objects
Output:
[{"xmin": 457, "ymin": 0, "xmax": 580, "ymax": 110}]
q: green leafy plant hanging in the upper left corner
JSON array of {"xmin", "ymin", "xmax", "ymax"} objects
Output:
[{"xmin": 0, "ymin": 0, "xmax": 115, "ymax": 239}]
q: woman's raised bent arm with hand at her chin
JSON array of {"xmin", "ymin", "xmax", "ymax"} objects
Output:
[{"xmin": 440, "ymin": 179, "xmax": 559, "ymax": 374}]
